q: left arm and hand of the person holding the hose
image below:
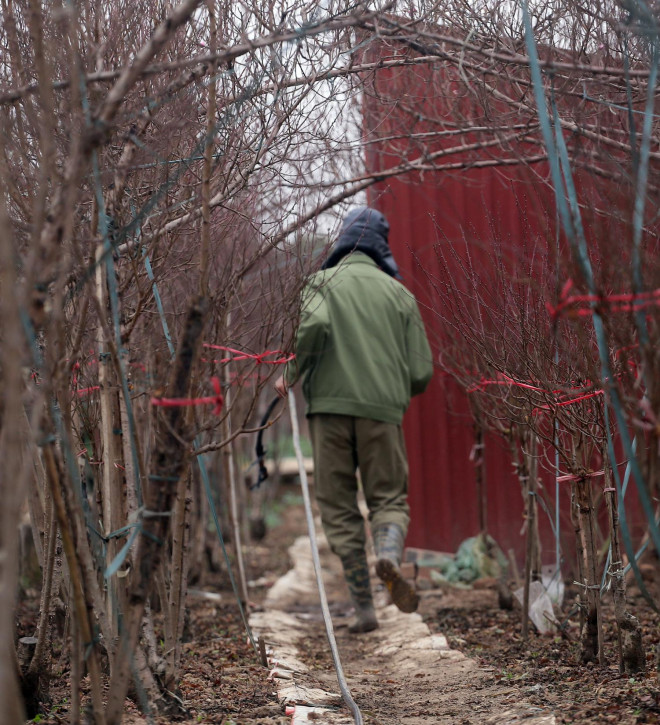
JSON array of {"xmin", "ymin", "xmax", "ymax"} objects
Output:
[{"xmin": 275, "ymin": 284, "xmax": 330, "ymax": 397}]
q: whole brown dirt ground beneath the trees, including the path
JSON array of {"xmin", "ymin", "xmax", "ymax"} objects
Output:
[{"xmin": 18, "ymin": 494, "xmax": 660, "ymax": 725}]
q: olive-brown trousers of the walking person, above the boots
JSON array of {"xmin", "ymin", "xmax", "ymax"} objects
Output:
[{"xmin": 309, "ymin": 414, "xmax": 410, "ymax": 557}]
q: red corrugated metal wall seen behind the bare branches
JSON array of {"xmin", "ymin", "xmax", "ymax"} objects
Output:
[{"xmin": 364, "ymin": 49, "xmax": 640, "ymax": 563}]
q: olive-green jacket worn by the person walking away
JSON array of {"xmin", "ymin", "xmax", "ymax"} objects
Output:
[{"xmin": 285, "ymin": 252, "xmax": 433, "ymax": 424}]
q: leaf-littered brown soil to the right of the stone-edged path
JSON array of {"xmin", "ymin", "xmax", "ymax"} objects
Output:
[{"xmin": 427, "ymin": 558, "xmax": 660, "ymax": 725}]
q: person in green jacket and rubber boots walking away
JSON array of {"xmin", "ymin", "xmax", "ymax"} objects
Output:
[{"xmin": 275, "ymin": 207, "xmax": 433, "ymax": 633}]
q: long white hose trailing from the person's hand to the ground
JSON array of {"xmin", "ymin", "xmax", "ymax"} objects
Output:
[{"xmin": 289, "ymin": 388, "xmax": 362, "ymax": 725}]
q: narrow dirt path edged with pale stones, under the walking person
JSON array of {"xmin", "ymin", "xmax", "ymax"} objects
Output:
[{"xmin": 251, "ymin": 536, "xmax": 555, "ymax": 725}]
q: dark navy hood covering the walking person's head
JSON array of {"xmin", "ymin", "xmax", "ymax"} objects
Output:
[{"xmin": 322, "ymin": 206, "xmax": 401, "ymax": 279}]
